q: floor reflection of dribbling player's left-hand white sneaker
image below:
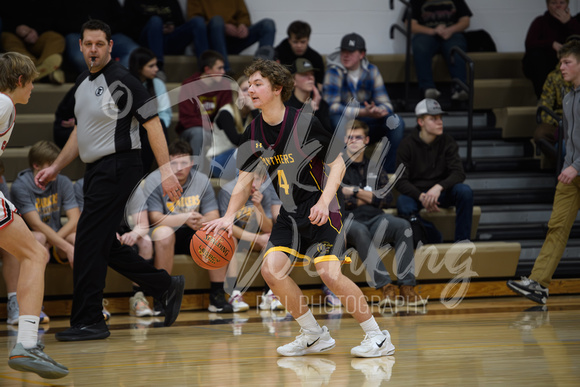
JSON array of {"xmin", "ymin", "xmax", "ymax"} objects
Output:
[{"xmin": 277, "ymin": 357, "xmax": 336, "ymax": 386}]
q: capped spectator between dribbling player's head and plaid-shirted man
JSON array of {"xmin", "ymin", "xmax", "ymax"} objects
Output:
[{"xmin": 284, "ymin": 58, "xmax": 334, "ymax": 133}]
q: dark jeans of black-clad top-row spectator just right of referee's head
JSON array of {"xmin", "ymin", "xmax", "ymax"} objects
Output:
[{"xmin": 139, "ymin": 16, "xmax": 209, "ymax": 63}]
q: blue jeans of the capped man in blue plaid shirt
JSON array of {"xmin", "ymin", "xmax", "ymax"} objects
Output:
[{"xmin": 330, "ymin": 114, "xmax": 405, "ymax": 173}]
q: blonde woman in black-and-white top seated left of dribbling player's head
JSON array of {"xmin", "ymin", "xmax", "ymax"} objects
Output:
[{"xmin": 207, "ymin": 76, "xmax": 259, "ymax": 181}]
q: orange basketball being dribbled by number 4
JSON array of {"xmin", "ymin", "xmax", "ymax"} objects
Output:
[{"xmin": 189, "ymin": 230, "xmax": 236, "ymax": 270}]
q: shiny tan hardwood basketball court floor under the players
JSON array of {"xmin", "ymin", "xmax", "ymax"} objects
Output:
[{"xmin": 0, "ymin": 296, "xmax": 580, "ymax": 387}]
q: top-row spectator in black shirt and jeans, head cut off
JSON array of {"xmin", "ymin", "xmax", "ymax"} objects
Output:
[{"xmin": 411, "ymin": 0, "xmax": 472, "ymax": 101}]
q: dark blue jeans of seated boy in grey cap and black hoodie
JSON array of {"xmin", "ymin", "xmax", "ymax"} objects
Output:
[{"xmin": 397, "ymin": 183, "xmax": 473, "ymax": 242}]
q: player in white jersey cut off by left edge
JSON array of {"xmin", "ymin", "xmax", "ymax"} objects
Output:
[{"xmin": 0, "ymin": 52, "xmax": 68, "ymax": 379}]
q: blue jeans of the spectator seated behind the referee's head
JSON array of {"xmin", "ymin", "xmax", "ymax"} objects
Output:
[{"xmin": 64, "ymin": 33, "xmax": 139, "ymax": 73}]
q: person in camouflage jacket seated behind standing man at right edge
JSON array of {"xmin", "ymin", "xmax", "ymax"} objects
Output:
[{"xmin": 534, "ymin": 66, "xmax": 574, "ymax": 161}]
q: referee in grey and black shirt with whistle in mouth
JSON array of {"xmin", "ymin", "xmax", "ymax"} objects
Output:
[{"xmin": 35, "ymin": 20, "xmax": 185, "ymax": 341}]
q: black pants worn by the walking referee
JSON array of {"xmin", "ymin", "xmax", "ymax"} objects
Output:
[{"xmin": 71, "ymin": 151, "xmax": 171, "ymax": 326}]
